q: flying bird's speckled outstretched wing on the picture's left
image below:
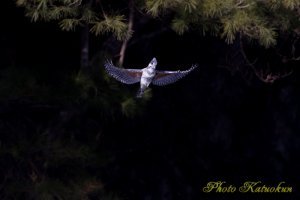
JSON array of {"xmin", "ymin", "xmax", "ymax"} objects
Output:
[{"xmin": 104, "ymin": 60, "xmax": 142, "ymax": 84}]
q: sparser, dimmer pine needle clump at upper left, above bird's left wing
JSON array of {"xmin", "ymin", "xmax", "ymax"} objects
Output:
[{"xmin": 16, "ymin": 0, "xmax": 127, "ymax": 40}]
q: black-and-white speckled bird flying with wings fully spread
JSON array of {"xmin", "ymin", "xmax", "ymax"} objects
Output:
[{"xmin": 104, "ymin": 58, "xmax": 198, "ymax": 98}]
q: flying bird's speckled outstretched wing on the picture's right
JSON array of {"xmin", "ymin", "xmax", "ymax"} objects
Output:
[{"xmin": 152, "ymin": 65, "xmax": 198, "ymax": 86}]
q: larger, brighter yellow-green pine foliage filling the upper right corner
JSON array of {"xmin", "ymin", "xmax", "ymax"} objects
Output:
[{"xmin": 146, "ymin": 0, "xmax": 300, "ymax": 47}]
